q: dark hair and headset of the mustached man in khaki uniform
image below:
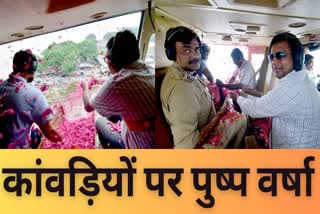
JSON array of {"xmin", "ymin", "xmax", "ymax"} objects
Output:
[{"xmin": 164, "ymin": 26, "xmax": 201, "ymax": 61}]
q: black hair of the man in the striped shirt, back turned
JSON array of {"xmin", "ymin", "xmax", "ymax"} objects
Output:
[{"xmin": 107, "ymin": 30, "xmax": 140, "ymax": 69}]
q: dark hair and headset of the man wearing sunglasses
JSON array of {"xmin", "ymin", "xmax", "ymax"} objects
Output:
[{"xmin": 270, "ymin": 33, "xmax": 304, "ymax": 71}]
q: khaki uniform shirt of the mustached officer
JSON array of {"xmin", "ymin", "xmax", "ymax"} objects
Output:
[{"xmin": 160, "ymin": 62, "xmax": 216, "ymax": 148}]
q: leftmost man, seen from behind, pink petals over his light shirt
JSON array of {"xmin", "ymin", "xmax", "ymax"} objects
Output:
[{"xmin": 0, "ymin": 50, "xmax": 62, "ymax": 148}]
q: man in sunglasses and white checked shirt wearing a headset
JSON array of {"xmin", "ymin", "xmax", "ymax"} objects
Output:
[{"xmin": 232, "ymin": 33, "xmax": 320, "ymax": 148}]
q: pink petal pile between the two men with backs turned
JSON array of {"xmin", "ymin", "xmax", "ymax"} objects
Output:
[{"xmin": 43, "ymin": 113, "xmax": 95, "ymax": 149}]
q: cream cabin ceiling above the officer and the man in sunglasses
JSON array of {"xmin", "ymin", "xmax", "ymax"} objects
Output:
[{"xmin": 156, "ymin": 0, "xmax": 320, "ymax": 46}]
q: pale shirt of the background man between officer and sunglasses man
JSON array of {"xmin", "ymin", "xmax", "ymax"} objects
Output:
[{"xmin": 237, "ymin": 59, "xmax": 257, "ymax": 88}]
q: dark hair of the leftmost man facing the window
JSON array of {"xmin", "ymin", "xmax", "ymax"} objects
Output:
[{"xmin": 12, "ymin": 49, "xmax": 38, "ymax": 74}]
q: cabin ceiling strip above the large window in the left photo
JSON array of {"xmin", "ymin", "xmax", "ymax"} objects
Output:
[{"xmin": 0, "ymin": 0, "xmax": 148, "ymax": 44}]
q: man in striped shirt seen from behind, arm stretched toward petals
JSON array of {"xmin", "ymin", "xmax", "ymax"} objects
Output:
[{"xmin": 83, "ymin": 30, "xmax": 157, "ymax": 148}]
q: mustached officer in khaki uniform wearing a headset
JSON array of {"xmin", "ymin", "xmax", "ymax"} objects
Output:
[{"xmin": 160, "ymin": 26, "xmax": 245, "ymax": 149}]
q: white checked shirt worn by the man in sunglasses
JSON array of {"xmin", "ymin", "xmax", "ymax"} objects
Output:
[{"xmin": 237, "ymin": 70, "xmax": 320, "ymax": 148}]
